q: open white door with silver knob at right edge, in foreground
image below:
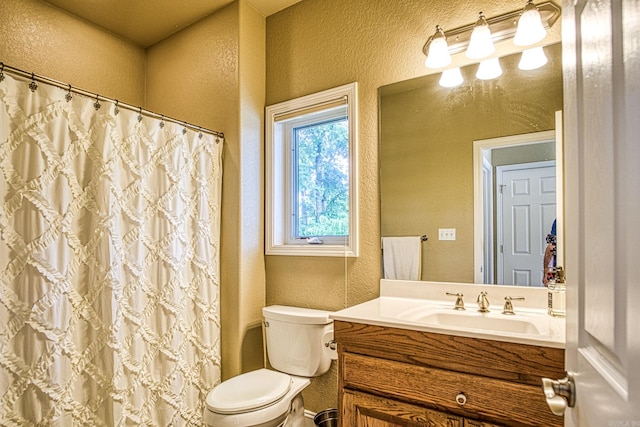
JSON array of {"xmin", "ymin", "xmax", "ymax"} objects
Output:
[{"xmin": 562, "ymin": 0, "xmax": 640, "ymax": 427}]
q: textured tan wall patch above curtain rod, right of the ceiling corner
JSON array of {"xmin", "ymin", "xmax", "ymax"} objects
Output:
[{"xmin": 145, "ymin": 3, "xmax": 239, "ymax": 132}]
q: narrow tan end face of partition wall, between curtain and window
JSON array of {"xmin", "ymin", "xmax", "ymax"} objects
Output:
[{"xmin": 236, "ymin": 0, "xmax": 266, "ymax": 373}]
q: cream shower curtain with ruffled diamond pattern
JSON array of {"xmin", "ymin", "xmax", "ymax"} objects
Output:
[{"xmin": 0, "ymin": 72, "xmax": 223, "ymax": 426}]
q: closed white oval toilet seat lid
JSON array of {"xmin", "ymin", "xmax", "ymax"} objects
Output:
[{"xmin": 206, "ymin": 369, "xmax": 292, "ymax": 415}]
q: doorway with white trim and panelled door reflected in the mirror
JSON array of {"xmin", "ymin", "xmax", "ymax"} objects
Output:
[{"xmin": 473, "ymin": 131, "xmax": 562, "ymax": 286}]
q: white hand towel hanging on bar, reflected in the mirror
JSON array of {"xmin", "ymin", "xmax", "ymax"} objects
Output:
[{"xmin": 382, "ymin": 236, "xmax": 422, "ymax": 280}]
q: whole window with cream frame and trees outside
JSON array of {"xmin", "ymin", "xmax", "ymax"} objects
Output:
[{"xmin": 265, "ymin": 83, "xmax": 358, "ymax": 256}]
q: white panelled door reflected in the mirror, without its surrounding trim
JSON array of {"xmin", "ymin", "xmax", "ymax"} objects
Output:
[{"xmin": 497, "ymin": 161, "xmax": 556, "ymax": 286}]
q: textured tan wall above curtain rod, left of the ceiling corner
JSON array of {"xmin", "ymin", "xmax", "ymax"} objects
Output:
[{"xmin": 0, "ymin": 0, "xmax": 145, "ymax": 105}]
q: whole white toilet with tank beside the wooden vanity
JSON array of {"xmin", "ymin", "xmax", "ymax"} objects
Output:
[{"xmin": 204, "ymin": 305, "xmax": 338, "ymax": 427}]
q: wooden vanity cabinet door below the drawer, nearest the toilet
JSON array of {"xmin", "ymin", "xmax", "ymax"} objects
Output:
[{"xmin": 340, "ymin": 390, "xmax": 464, "ymax": 427}]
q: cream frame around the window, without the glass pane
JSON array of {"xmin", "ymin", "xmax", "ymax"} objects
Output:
[{"xmin": 265, "ymin": 83, "xmax": 359, "ymax": 257}]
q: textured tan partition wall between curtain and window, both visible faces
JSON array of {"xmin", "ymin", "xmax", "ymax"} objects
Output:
[{"xmin": 147, "ymin": 0, "xmax": 265, "ymax": 379}]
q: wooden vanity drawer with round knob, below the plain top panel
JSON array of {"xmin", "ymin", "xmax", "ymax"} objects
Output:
[{"xmin": 340, "ymin": 353, "xmax": 563, "ymax": 427}]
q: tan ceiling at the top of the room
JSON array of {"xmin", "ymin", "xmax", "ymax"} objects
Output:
[{"xmin": 46, "ymin": 0, "xmax": 300, "ymax": 47}]
